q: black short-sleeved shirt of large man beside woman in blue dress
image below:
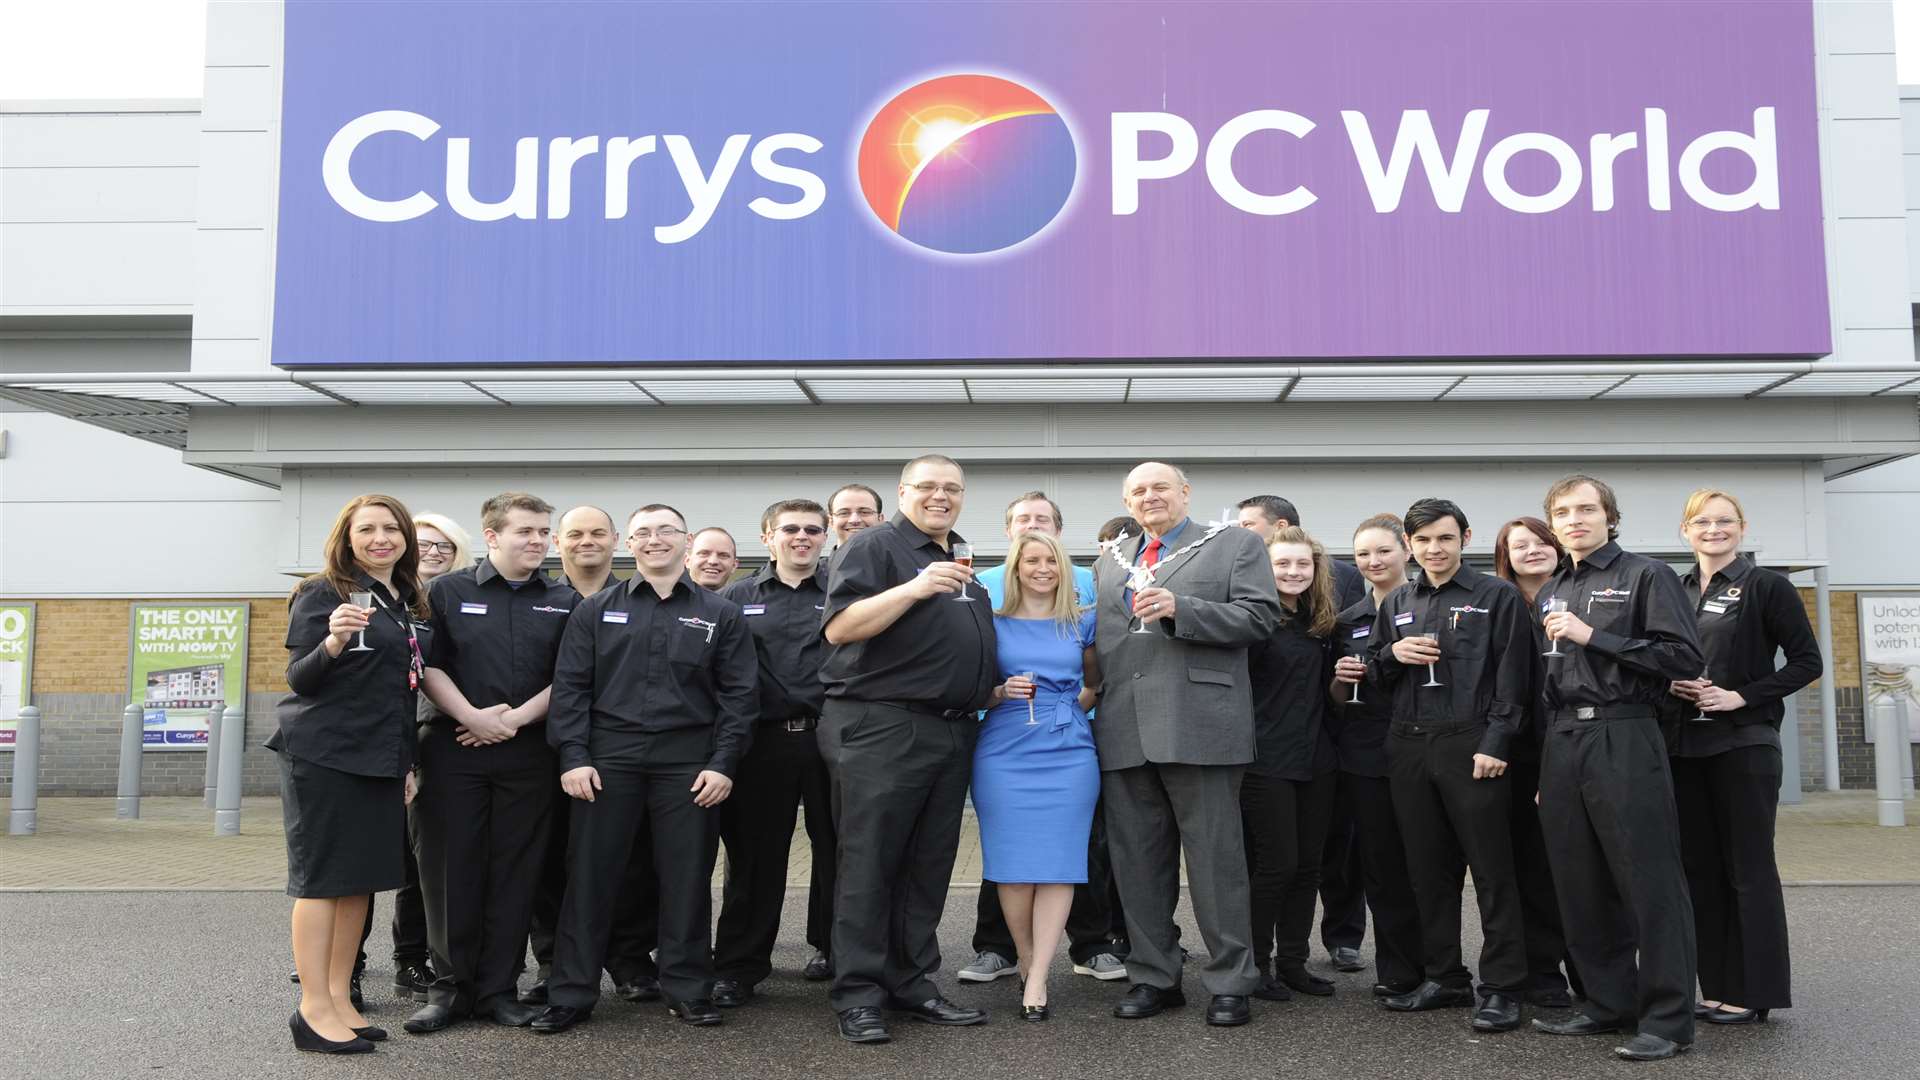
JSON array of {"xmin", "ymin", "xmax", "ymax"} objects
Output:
[{"xmin": 820, "ymin": 513, "xmax": 996, "ymax": 711}]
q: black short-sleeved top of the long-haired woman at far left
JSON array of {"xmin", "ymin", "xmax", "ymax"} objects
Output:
[{"xmin": 267, "ymin": 571, "xmax": 432, "ymax": 776}]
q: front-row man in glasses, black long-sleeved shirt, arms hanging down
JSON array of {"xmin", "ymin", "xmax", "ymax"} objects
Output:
[{"xmin": 534, "ymin": 503, "xmax": 758, "ymax": 1034}]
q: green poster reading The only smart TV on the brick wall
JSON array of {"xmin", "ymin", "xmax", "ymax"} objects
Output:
[{"xmin": 127, "ymin": 603, "xmax": 248, "ymax": 749}]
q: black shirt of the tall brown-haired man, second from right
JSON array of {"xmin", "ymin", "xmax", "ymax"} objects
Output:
[{"xmin": 1534, "ymin": 540, "xmax": 1705, "ymax": 711}]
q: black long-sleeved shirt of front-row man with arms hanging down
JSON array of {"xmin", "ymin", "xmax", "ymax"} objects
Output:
[{"xmin": 547, "ymin": 573, "xmax": 758, "ymax": 776}]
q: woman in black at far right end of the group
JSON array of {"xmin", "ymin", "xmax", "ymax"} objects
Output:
[{"xmin": 1667, "ymin": 490, "xmax": 1824, "ymax": 1024}]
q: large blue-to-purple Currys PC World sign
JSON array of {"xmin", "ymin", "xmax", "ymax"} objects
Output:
[{"xmin": 273, "ymin": 0, "xmax": 1830, "ymax": 365}]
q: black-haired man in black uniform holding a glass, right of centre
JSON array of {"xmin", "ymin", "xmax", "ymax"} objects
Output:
[{"xmin": 1369, "ymin": 500, "xmax": 1534, "ymax": 1032}]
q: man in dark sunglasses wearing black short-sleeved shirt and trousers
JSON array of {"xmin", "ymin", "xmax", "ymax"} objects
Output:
[{"xmin": 714, "ymin": 500, "xmax": 835, "ymax": 1009}]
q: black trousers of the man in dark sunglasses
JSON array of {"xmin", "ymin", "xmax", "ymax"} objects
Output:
[{"xmin": 714, "ymin": 724, "xmax": 837, "ymax": 986}]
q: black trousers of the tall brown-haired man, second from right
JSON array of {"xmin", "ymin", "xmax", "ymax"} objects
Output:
[{"xmin": 1540, "ymin": 715, "xmax": 1695, "ymax": 1043}]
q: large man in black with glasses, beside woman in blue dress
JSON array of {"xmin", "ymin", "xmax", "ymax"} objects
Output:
[{"xmin": 818, "ymin": 454, "xmax": 996, "ymax": 1042}]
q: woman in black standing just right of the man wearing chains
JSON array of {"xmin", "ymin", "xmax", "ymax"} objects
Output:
[{"xmin": 1240, "ymin": 527, "xmax": 1338, "ymax": 1001}]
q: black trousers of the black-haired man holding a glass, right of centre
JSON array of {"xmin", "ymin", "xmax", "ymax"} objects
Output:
[{"xmin": 1386, "ymin": 724, "xmax": 1526, "ymax": 995}]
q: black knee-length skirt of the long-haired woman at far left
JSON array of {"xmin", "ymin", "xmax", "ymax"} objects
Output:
[{"xmin": 278, "ymin": 753, "xmax": 407, "ymax": 897}]
